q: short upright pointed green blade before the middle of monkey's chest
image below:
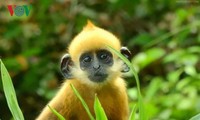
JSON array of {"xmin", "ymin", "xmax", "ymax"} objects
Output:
[{"xmin": 94, "ymin": 95, "xmax": 108, "ymax": 120}]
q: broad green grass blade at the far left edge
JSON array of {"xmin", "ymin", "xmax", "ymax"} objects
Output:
[{"xmin": 0, "ymin": 59, "xmax": 24, "ymax": 120}]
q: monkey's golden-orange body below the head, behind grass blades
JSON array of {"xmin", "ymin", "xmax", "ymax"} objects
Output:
[{"xmin": 37, "ymin": 78, "xmax": 128, "ymax": 120}]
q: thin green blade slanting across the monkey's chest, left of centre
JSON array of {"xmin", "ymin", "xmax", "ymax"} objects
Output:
[{"xmin": 70, "ymin": 84, "xmax": 95, "ymax": 120}]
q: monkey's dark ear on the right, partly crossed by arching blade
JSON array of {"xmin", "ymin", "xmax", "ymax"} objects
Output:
[{"xmin": 120, "ymin": 47, "xmax": 131, "ymax": 73}]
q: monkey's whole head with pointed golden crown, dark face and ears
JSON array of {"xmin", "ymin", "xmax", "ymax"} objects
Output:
[{"xmin": 61, "ymin": 21, "xmax": 130, "ymax": 84}]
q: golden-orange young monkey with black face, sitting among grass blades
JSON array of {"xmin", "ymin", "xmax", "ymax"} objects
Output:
[{"xmin": 36, "ymin": 21, "xmax": 131, "ymax": 120}]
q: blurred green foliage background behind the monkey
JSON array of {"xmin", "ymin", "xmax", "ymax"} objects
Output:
[{"xmin": 0, "ymin": 0, "xmax": 200, "ymax": 120}]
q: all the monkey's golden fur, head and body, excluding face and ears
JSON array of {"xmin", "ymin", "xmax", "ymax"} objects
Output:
[{"xmin": 37, "ymin": 22, "xmax": 128, "ymax": 120}]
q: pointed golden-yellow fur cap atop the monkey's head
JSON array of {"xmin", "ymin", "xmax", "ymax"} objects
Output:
[{"xmin": 68, "ymin": 21, "xmax": 121, "ymax": 62}]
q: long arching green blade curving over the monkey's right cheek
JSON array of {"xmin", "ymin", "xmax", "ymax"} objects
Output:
[{"xmin": 107, "ymin": 46, "xmax": 147, "ymax": 120}]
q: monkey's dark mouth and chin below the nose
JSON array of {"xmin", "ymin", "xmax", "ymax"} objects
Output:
[{"xmin": 88, "ymin": 73, "xmax": 108, "ymax": 82}]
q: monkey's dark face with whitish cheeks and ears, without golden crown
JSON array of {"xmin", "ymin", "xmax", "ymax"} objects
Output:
[{"xmin": 61, "ymin": 47, "xmax": 131, "ymax": 83}]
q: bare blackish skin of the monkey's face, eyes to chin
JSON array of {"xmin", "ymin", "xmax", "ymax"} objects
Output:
[{"xmin": 79, "ymin": 49, "xmax": 113, "ymax": 82}]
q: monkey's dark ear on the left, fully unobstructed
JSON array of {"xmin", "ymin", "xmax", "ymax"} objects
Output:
[{"xmin": 60, "ymin": 54, "xmax": 73, "ymax": 79}]
